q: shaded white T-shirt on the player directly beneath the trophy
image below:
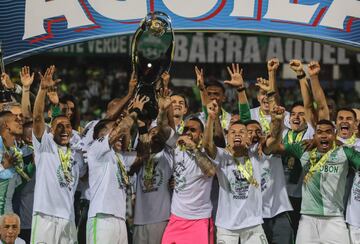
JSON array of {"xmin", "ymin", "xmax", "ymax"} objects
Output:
[{"xmin": 134, "ymin": 148, "xmax": 174, "ymax": 225}]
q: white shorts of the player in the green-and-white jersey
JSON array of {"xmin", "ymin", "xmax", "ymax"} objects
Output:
[{"xmin": 296, "ymin": 215, "xmax": 350, "ymax": 244}]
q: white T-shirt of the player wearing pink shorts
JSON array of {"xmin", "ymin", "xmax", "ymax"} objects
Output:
[{"xmin": 171, "ymin": 147, "xmax": 213, "ymax": 219}]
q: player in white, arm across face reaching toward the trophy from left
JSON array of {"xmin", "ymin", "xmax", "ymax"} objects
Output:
[{"xmin": 86, "ymin": 97, "xmax": 148, "ymax": 244}]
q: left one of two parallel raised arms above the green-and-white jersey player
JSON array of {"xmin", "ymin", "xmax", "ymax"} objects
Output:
[{"xmin": 289, "ymin": 59, "xmax": 317, "ymax": 127}]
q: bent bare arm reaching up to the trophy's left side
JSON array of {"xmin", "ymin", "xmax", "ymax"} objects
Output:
[{"xmin": 106, "ymin": 71, "xmax": 137, "ymax": 120}]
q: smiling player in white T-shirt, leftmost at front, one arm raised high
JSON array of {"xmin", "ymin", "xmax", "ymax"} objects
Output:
[{"xmin": 31, "ymin": 66, "xmax": 84, "ymax": 244}]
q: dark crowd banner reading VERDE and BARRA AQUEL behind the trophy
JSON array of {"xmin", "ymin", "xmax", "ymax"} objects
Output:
[{"xmin": 46, "ymin": 33, "xmax": 360, "ymax": 65}]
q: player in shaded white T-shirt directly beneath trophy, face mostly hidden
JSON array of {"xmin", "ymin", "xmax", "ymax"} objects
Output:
[{"xmin": 133, "ymin": 123, "xmax": 173, "ymax": 244}]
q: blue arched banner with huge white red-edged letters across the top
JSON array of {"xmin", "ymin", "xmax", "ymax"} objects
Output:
[{"xmin": 0, "ymin": 0, "xmax": 360, "ymax": 63}]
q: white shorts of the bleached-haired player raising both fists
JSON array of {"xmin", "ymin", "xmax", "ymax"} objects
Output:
[{"xmin": 216, "ymin": 225, "xmax": 268, "ymax": 244}]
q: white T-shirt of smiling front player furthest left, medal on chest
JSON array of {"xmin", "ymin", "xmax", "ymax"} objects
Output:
[{"xmin": 32, "ymin": 131, "xmax": 85, "ymax": 221}]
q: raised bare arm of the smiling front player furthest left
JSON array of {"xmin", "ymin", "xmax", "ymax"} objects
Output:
[{"xmin": 33, "ymin": 65, "xmax": 56, "ymax": 140}]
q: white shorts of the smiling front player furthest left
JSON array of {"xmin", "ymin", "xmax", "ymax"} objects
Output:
[{"xmin": 30, "ymin": 213, "xmax": 77, "ymax": 244}]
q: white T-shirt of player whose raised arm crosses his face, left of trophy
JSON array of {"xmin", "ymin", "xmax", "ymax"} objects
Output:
[{"xmin": 87, "ymin": 136, "xmax": 136, "ymax": 220}]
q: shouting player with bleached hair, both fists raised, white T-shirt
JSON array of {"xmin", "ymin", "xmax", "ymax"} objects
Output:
[{"xmin": 204, "ymin": 98, "xmax": 285, "ymax": 243}]
